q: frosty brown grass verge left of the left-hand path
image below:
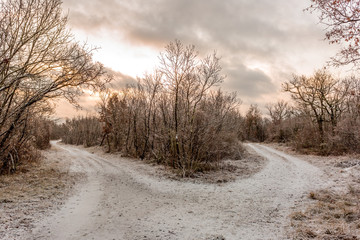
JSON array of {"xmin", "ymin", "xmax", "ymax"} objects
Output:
[{"xmin": 0, "ymin": 150, "xmax": 82, "ymax": 239}]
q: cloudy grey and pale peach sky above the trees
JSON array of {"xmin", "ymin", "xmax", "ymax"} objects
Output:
[{"xmin": 58, "ymin": 0, "xmax": 344, "ymax": 116}]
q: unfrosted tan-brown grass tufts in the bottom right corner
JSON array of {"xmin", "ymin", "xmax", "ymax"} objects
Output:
[{"xmin": 290, "ymin": 186, "xmax": 360, "ymax": 240}]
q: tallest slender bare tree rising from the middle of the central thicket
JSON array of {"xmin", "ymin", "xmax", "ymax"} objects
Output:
[{"xmin": 160, "ymin": 40, "xmax": 224, "ymax": 169}]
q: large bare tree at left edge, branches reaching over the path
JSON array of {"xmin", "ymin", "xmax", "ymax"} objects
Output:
[{"xmin": 0, "ymin": 0, "xmax": 106, "ymax": 172}]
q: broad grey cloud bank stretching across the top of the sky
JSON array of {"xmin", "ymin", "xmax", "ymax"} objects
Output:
[{"xmin": 64, "ymin": 0, "xmax": 326, "ymax": 59}]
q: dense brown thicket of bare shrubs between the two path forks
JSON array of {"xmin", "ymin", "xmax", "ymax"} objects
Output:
[{"xmin": 100, "ymin": 41, "xmax": 242, "ymax": 175}]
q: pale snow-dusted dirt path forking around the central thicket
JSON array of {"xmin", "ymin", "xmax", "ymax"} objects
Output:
[{"xmin": 31, "ymin": 142, "xmax": 324, "ymax": 240}]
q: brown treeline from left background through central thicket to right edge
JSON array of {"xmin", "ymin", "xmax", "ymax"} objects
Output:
[{"xmin": 56, "ymin": 68, "xmax": 360, "ymax": 176}]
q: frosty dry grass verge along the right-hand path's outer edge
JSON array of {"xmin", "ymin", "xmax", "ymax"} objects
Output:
[{"xmin": 271, "ymin": 144, "xmax": 360, "ymax": 240}]
